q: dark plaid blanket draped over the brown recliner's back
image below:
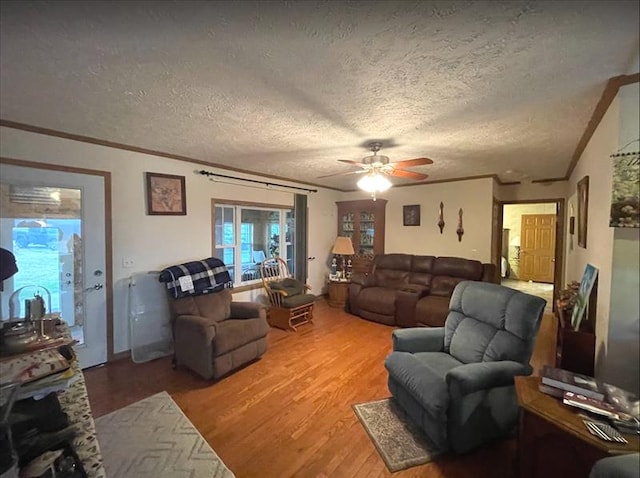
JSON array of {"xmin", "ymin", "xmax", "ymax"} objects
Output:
[{"xmin": 158, "ymin": 257, "xmax": 233, "ymax": 299}]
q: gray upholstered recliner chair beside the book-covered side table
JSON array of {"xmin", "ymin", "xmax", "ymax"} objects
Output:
[{"xmin": 385, "ymin": 281, "xmax": 546, "ymax": 453}]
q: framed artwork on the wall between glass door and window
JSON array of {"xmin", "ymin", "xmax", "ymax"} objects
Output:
[{"xmin": 146, "ymin": 173, "xmax": 187, "ymax": 216}]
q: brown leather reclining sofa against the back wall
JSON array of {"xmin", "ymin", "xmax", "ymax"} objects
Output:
[{"xmin": 349, "ymin": 254, "xmax": 498, "ymax": 327}]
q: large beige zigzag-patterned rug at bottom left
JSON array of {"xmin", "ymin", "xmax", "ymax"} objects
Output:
[{"xmin": 96, "ymin": 392, "xmax": 234, "ymax": 478}]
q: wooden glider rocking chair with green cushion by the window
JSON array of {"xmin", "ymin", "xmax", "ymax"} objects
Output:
[{"xmin": 260, "ymin": 257, "xmax": 316, "ymax": 331}]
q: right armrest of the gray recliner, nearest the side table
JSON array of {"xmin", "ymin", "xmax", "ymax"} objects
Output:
[{"xmin": 445, "ymin": 360, "xmax": 533, "ymax": 396}]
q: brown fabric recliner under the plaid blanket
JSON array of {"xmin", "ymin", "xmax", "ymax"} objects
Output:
[{"xmin": 171, "ymin": 289, "xmax": 269, "ymax": 379}]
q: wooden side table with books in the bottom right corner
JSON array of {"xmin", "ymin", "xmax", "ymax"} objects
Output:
[{"xmin": 515, "ymin": 377, "xmax": 640, "ymax": 478}]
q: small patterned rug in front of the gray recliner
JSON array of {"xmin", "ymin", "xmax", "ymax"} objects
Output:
[{"xmin": 353, "ymin": 398, "xmax": 437, "ymax": 472}]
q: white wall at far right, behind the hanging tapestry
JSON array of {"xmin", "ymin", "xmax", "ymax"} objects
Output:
[{"xmin": 565, "ymin": 79, "xmax": 640, "ymax": 393}]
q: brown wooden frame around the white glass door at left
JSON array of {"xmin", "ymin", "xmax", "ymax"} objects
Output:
[{"xmin": 0, "ymin": 156, "xmax": 117, "ymax": 362}]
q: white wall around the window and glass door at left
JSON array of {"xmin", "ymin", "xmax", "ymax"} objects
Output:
[{"xmin": 0, "ymin": 127, "xmax": 338, "ymax": 353}]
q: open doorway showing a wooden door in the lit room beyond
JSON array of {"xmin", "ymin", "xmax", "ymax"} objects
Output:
[{"xmin": 498, "ymin": 199, "xmax": 564, "ymax": 312}]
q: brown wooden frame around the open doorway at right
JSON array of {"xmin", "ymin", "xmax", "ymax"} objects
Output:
[{"xmin": 492, "ymin": 198, "xmax": 566, "ymax": 311}]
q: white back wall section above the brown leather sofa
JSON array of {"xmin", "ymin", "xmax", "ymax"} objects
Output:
[{"xmin": 342, "ymin": 178, "xmax": 493, "ymax": 262}]
